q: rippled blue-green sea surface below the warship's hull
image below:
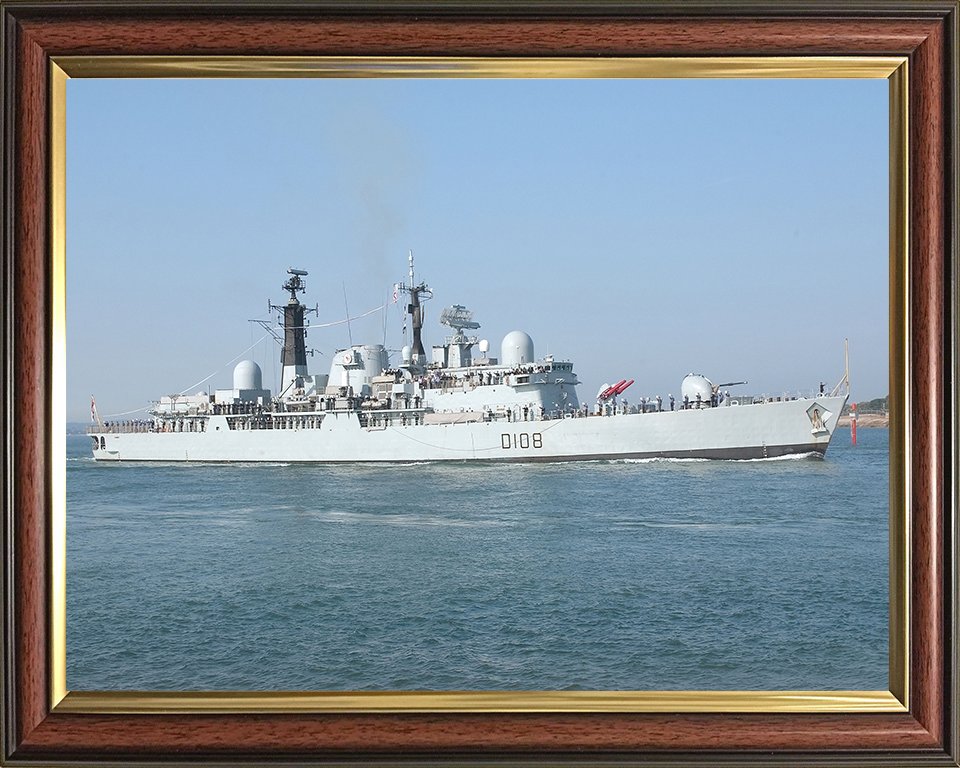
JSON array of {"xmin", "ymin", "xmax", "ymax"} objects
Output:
[{"xmin": 67, "ymin": 429, "xmax": 889, "ymax": 691}]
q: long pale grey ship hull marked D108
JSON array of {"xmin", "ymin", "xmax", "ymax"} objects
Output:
[{"xmin": 91, "ymin": 396, "xmax": 846, "ymax": 463}]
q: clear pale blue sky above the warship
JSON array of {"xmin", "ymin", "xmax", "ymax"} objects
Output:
[{"xmin": 67, "ymin": 79, "xmax": 888, "ymax": 421}]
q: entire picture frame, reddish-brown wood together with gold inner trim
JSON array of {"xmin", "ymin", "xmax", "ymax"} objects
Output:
[{"xmin": 0, "ymin": 2, "xmax": 960, "ymax": 765}]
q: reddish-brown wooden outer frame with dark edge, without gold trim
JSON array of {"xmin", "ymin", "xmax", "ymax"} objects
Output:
[{"xmin": 0, "ymin": 0, "xmax": 960, "ymax": 767}]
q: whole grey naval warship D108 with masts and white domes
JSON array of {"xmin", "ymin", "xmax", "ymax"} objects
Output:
[{"xmin": 87, "ymin": 254, "xmax": 848, "ymax": 462}]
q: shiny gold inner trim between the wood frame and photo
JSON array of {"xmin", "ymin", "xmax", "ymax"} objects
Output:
[{"xmin": 49, "ymin": 56, "xmax": 910, "ymax": 714}]
